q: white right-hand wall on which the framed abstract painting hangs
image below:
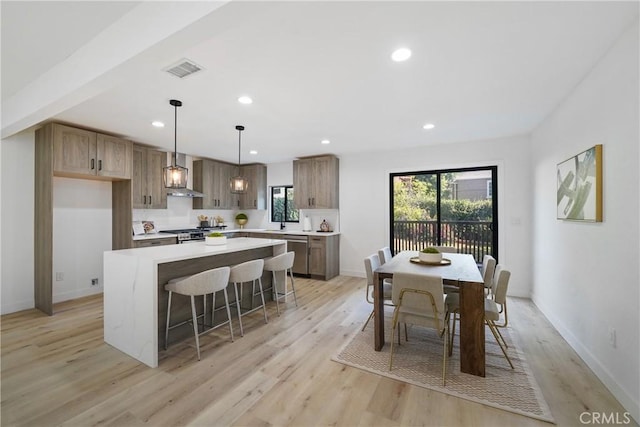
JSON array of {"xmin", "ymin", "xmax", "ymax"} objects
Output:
[{"xmin": 532, "ymin": 22, "xmax": 640, "ymax": 420}]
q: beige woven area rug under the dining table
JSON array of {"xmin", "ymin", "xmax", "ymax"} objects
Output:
[{"xmin": 332, "ymin": 319, "xmax": 554, "ymax": 423}]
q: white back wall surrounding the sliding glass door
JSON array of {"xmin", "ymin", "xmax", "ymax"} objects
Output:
[{"xmin": 340, "ymin": 136, "xmax": 531, "ymax": 297}]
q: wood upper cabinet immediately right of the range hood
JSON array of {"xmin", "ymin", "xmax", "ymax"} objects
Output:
[{"xmin": 193, "ymin": 159, "xmax": 235, "ymax": 209}]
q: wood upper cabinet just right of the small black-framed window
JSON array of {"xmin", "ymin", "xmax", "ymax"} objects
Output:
[{"xmin": 293, "ymin": 155, "xmax": 339, "ymax": 209}]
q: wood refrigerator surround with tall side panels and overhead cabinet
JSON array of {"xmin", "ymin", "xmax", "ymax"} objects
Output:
[{"xmin": 33, "ymin": 123, "xmax": 133, "ymax": 315}]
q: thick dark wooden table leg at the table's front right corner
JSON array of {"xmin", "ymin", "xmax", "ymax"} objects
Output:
[{"xmin": 460, "ymin": 282, "xmax": 485, "ymax": 377}]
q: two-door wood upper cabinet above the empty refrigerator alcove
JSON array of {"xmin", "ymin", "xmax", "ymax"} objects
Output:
[{"xmin": 52, "ymin": 123, "xmax": 133, "ymax": 180}]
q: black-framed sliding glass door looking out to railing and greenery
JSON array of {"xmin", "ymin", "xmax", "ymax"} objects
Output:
[{"xmin": 389, "ymin": 166, "xmax": 498, "ymax": 263}]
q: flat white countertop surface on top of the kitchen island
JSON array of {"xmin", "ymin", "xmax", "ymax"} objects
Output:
[{"xmin": 108, "ymin": 235, "xmax": 285, "ymax": 263}]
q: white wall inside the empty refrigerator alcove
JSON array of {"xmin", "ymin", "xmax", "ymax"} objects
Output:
[{"xmin": 53, "ymin": 177, "xmax": 111, "ymax": 303}]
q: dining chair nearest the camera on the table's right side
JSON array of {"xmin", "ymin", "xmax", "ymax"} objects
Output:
[{"xmin": 445, "ymin": 265, "xmax": 513, "ymax": 369}]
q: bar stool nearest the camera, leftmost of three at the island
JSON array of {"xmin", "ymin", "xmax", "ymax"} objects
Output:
[{"xmin": 164, "ymin": 267, "xmax": 233, "ymax": 360}]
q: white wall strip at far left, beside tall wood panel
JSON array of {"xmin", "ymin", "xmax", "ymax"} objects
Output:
[{"xmin": 0, "ymin": 131, "xmax": 35, "ymax": 314}]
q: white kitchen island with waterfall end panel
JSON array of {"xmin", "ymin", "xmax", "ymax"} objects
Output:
[{"xmin": 104, "ymin": 237, "xmax": 287, "ymax": 368}]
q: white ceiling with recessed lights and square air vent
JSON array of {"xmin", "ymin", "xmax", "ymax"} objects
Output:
[{"xmin": 0, "ymin": 1, "xmax": 638, "ymax": 163}]
